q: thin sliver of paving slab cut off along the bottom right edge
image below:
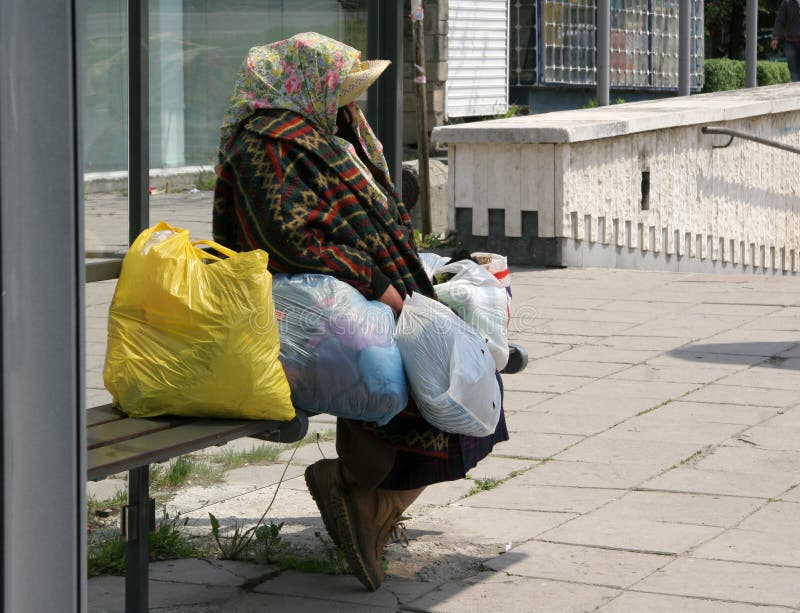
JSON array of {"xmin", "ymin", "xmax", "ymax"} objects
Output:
[{"xmin": 598, "ymin": 592, "xmax": 792, "ymax": 613}]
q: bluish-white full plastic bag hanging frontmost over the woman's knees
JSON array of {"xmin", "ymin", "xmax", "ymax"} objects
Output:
[{"xmin": 395, "ymin": 293, "xmax": 501, "ymax": 436}]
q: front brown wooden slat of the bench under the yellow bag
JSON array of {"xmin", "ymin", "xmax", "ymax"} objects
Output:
[{"xmin": 86, "ymin": 419, "xmax": 285, "ymax": 481}]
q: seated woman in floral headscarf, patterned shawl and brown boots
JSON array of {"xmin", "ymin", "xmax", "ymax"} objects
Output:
[{"xmin": 213, "ymin": 33, "xmax": 508, "ymax": 590}]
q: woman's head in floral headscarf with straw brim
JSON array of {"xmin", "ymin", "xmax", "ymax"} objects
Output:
[{"xmin": 220, "ymin": 32, "xmax": 389, "ymax": 153}]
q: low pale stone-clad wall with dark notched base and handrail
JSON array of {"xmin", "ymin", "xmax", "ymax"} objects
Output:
[{"xmin": 433, "ymin": 84, "xmax": 800, "ymax": 273}]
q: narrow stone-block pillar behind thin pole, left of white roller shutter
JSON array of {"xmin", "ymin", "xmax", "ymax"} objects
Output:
[{"xmin": 403, "ymin": 0, "xmax": 448, "ymax": 147}]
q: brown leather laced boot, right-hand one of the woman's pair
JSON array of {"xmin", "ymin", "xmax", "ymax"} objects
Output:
[{"xmin": 332, "ymin": 483, "xmax": 405, "ymax": 592}]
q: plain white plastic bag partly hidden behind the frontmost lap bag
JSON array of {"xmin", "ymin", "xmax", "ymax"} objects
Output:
[{"xmin": 434, "ymin": 260, "xmax": 508, "ymax": 370}]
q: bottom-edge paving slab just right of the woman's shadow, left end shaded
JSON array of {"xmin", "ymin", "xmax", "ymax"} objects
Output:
[{"xmin": 409, "ymin": 573, "xmax": 619, "ymax": 613}]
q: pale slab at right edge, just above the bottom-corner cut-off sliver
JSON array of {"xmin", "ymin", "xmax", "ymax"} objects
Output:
[{"xmin": 634, "ymin": 558, "xmax": 800, "ymax": 607}]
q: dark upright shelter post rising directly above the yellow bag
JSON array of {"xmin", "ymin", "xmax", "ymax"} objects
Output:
[{"xmin": 128, "ymin": 0, "xmax": 150, "ymax": 244}]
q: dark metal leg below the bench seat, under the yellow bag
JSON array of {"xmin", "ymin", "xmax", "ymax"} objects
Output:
[{"xmin": 123, "ymin": 466, "xmax": 152, "ymax": 613}]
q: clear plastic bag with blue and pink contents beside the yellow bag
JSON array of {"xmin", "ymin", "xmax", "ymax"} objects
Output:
[{"xmin": 273, "ymin": 274, "xmax": 408, "ymax": 425}]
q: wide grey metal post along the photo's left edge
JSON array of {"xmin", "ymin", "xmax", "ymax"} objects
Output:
[{"xmin": 0, "ymin": 0, "xmax": 86, "ymax": 613}]
